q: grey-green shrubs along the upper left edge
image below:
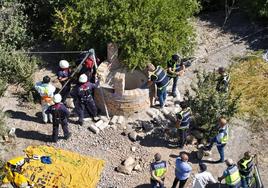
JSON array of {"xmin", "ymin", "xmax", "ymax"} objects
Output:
[{"xmin": 0, "ymin": 0, "xmax": 38, "ymax": 95}]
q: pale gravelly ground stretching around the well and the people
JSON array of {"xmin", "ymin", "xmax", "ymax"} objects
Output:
[{"xmin": 0, "ymin": 13, "xmax": 268, "ymax": 188}]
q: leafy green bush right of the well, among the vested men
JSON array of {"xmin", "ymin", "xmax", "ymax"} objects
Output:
[{"xmin": 185, "ymin": 72, "xmax": 240, "ymax": 130}]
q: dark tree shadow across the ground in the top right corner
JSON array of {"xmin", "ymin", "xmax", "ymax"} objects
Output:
[{"xmin": 199, "ymin": 11, "xmax": 268, "ymax": 50}]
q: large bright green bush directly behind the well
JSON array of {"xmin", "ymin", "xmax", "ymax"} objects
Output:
[{"xmin": 53, "ymin": 0, "xmax": 199, "ymax": 69}]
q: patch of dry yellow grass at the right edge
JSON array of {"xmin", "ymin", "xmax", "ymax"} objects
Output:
[{"xmin": 231, "ymin": 56, "xmax": 268, "ymax": 119}]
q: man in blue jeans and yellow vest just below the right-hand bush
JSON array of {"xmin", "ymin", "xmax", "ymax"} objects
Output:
[{"xmin": 204, "ymin": 117, "xmax": 229, "ymax": 163}]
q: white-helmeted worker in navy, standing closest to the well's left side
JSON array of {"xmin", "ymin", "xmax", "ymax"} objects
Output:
[{"xmin": 72, "ymin": 74, "xmax": 99, "ymax": 125}]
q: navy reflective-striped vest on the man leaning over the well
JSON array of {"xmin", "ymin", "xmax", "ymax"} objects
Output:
[{"xmin": 152, "ymin": 66, "xmax": 169, "ymax": 90}]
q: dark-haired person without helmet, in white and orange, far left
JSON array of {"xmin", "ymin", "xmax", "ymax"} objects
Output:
[{"xmin": 34, "ymin": 76, "xmax": 56, "ymax": 123}]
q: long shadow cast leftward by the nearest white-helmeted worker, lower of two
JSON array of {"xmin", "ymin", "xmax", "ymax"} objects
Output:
[{"xmin": 15, "ymin": 128, "xmax": 52, "ymax": 142}]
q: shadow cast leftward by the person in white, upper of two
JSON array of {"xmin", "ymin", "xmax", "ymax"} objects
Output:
[{"xmin": 6, "ymin": 110, "xmax": 42, "ymax": 123}]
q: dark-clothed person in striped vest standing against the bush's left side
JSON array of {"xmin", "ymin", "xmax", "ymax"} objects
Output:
[{"xmin": 176, "ymin": 102, "xmax": 192, "ymax": 148}]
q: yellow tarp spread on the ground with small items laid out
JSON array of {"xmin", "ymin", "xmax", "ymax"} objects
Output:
[{"xmin": 20, "ymin": 146, "xmax": 104, "ymax": 188}]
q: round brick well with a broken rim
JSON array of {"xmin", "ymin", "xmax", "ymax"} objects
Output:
[{"xmin": 95, "ymin": 62, "xmax": 150, "ymax": 116}]
